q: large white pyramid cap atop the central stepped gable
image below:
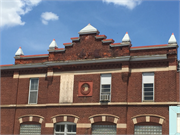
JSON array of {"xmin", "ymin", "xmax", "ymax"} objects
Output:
[{"xmin": 78, "ymin": 23, "xmax": 99, "ymax": 35}]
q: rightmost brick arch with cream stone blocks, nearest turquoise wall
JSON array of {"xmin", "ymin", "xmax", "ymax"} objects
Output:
[{"xmin": 131, "ymin": 114, "xmax": 165, "ymax": 125}]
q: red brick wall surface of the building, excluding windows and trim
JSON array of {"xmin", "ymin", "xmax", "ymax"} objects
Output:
[{"xmin": 1, "ymin": 31, "xmax": 180, "ymax": 134}]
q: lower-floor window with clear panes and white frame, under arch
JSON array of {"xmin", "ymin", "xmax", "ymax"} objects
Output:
[{"xmin": 54, "ymin": 122, "xmax": 76, "ymax": 135}]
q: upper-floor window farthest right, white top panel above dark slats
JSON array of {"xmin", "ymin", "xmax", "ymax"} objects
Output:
[{"xmin": 142, "ymin": 73, "xmax": 154, "ymax": 101}]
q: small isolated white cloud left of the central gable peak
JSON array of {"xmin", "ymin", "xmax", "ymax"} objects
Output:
[{"xmin": 41, "ymin": 12, "xmax": 59, "ymax": 25}]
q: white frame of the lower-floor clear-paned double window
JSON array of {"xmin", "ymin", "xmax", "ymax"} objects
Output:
[{"xmin": 54, "ymin": 122, "xmax": 77, "ymax": 135}]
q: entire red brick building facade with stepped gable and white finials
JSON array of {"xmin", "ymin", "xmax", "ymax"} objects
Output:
[{"xmin": 1, "ymin": 24, "xmax": 180, "ymax": 135}]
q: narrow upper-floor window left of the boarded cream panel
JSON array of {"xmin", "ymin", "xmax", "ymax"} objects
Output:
[{"xmin": 28, "ymin": 78, "xmax": 39, "ymax": 104}]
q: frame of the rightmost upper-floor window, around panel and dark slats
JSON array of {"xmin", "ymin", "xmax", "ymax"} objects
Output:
[{"xmin": 142, "ymin": 72, "xmax": 155, "ymax": 102}]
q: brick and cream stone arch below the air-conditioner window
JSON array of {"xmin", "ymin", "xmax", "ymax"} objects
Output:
[{"xmin": 89, "ymin": 114, "xmax": 119, "ymax": 124}]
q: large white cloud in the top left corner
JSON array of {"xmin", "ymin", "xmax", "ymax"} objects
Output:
[{"xmin": 0, "ymin": 0, "xmax": 41, "ymax": 27}]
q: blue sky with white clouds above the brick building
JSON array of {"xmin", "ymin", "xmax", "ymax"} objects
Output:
[{"xmin": 0, "ymin": 0, "xmax": 180, "ymax": 65}]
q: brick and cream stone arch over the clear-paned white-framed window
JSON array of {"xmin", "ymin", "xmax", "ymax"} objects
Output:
[{"xmin": 51, "ymin": 114, "xmax": 79, "ymax": 123}]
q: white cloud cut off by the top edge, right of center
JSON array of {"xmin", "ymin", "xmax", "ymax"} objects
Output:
[{"xmin": 103, "ymin": 0, "xmax": 142, "ymax": 9}]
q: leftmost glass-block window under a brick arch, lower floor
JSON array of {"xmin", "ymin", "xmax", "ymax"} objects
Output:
[{"xmin": 20, "ymin": 124, "xmax": 41, "ymax": 135}]
